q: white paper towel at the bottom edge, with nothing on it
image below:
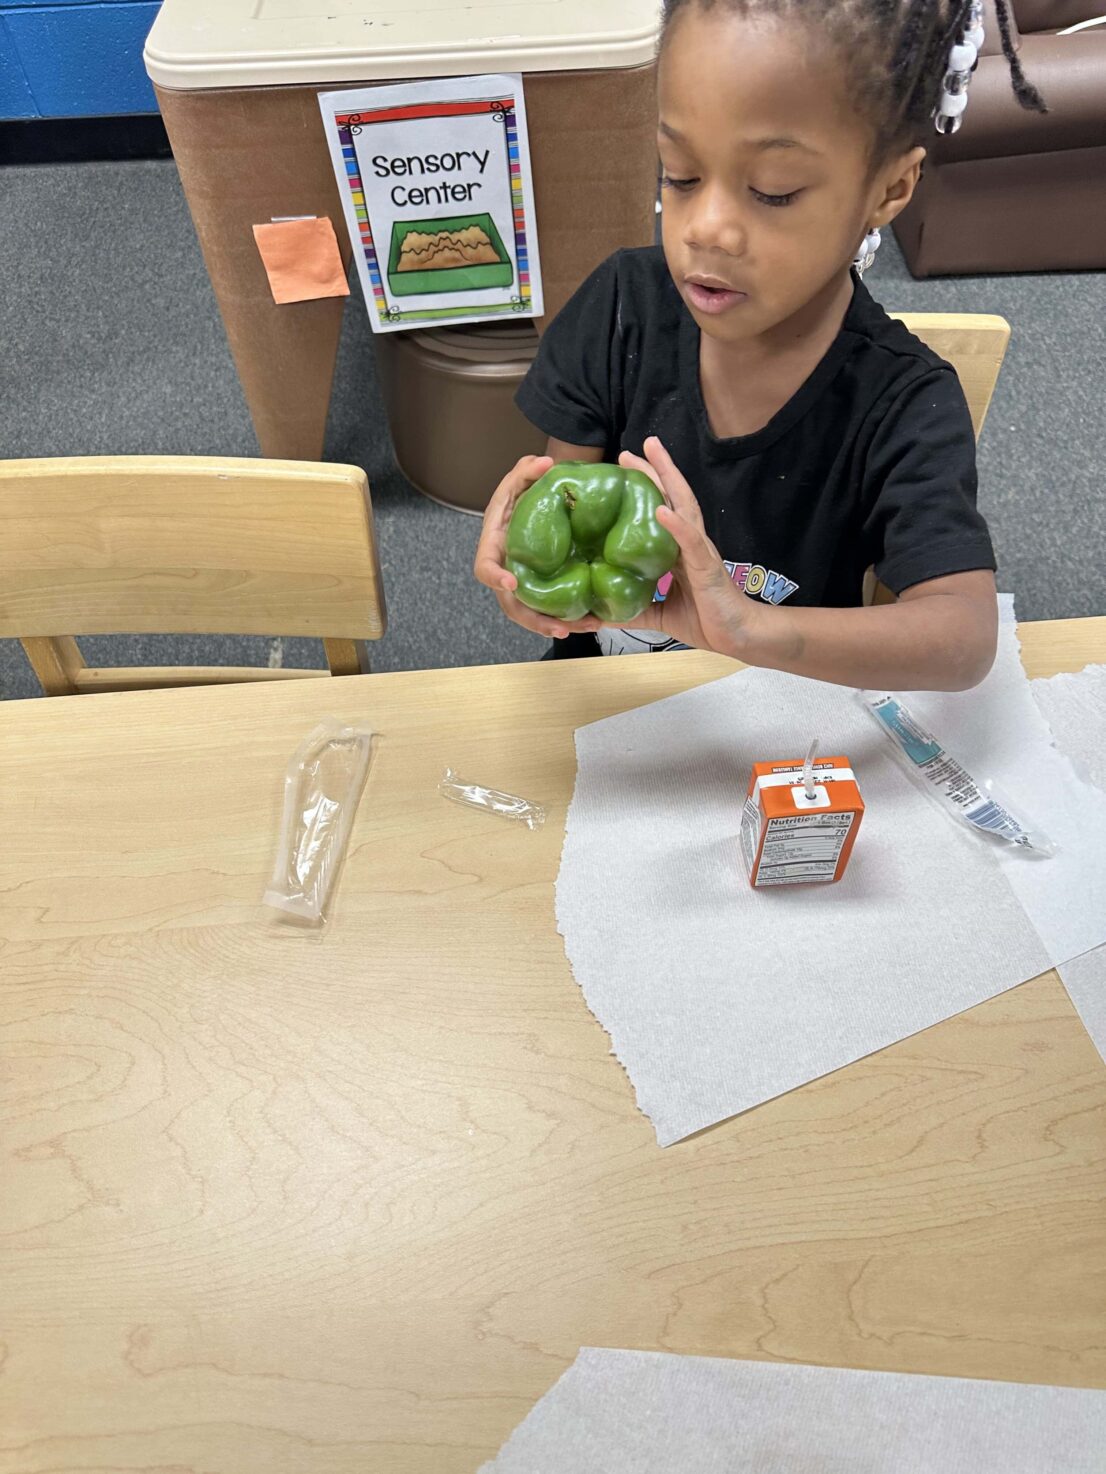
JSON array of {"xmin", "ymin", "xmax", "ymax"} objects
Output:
[{"xmin": 479, "ymin": 1347, "xmax": 1106, "ymax": 1474}]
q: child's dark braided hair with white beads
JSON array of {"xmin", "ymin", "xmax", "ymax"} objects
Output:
[{"xmin": 661, "ymin": 0, "xmax": 1047, "ymax": 155}]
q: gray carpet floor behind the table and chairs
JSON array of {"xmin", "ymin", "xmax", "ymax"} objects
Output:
[{"xmin": 0, "ymin": 161, "xmax": 1106, "ymax": 697}]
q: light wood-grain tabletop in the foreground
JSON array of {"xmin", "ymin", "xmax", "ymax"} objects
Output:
[{"xmin": 0, "ymin": 619, "xmax": 1106, "ymax": 1474}]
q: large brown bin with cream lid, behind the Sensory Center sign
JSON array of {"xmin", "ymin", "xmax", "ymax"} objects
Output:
[{"xmin": 145, "ymin": 0, "xmax": 659, "ymax": 460}]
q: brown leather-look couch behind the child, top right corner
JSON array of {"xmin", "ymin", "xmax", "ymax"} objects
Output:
[{"xmin": 895, "ymin": 0, "xmax": 1106, "ymax": 277}]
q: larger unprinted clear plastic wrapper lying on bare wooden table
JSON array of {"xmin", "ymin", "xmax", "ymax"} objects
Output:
[{"xmin": 264, "ymin": 718, "xmax": 373, "ymax": 926}]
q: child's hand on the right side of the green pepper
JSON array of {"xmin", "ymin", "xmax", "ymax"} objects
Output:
[{"xmin": 618, "ymin": 435, "xmax": 755, "ymax": 654}]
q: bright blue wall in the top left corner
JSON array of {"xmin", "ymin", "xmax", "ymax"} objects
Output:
[{"xmin": 0, "ymin": 0, "xmax": 158, "ymax": 118}]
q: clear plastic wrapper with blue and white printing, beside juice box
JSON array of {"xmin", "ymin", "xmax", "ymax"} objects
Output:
[{"xmin": 857, "ymin": 691, "xmax": 1056, "ymax": 859}]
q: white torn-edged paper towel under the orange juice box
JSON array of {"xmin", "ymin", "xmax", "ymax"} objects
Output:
[{"xmin": 556, "ymin": 624, "xmax": 1106, "ymax": 1145}]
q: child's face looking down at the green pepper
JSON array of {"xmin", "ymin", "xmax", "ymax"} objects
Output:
[{"xmin": 658, "ymin": 4, "xmax": 902, "ymax": 343}]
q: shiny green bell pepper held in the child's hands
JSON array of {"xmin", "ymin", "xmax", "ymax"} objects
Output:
[{"xmin": 507, "ymin": 461, "xmax": 680, "ymax": 624}]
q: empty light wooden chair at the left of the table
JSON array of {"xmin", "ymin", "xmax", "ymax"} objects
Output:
[{"xmin": 0, "ymin": 455, "xmax": 385, "ymax": 696}]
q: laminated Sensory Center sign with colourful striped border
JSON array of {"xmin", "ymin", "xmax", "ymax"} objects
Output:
[{"xmin": 319, "ymin": 74, "xmax": 541, "ymax": 333}]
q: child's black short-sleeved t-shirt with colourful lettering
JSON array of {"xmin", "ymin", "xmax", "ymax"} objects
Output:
[{"xmin": 518, "ymin": 246, "xmax": 995, "ymax": 649}]
